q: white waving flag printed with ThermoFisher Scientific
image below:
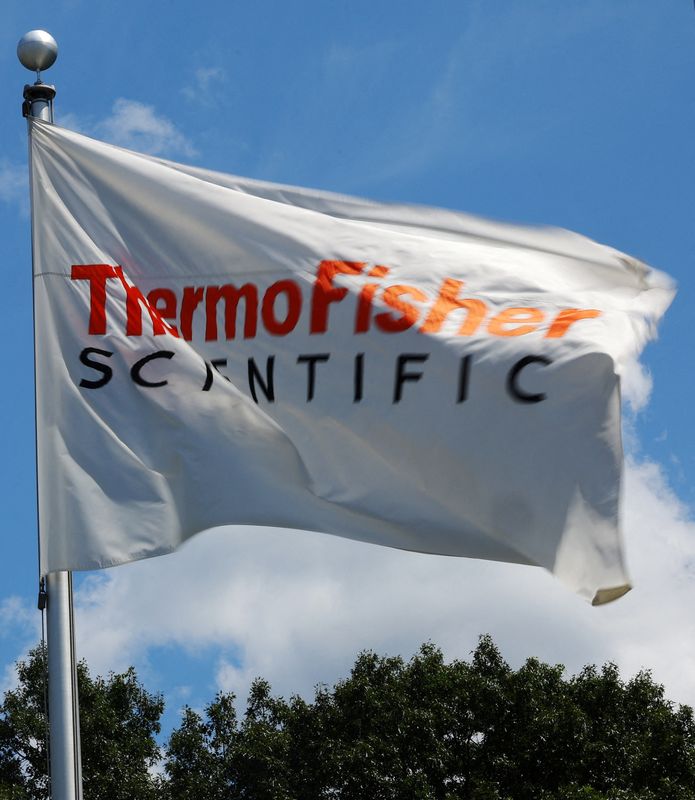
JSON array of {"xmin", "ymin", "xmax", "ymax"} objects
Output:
[{"xmin": 30, "ymin": 120, "xmax": 674, "ymax": 603}]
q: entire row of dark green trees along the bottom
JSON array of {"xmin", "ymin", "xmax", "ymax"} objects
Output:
[{"xmin": 0, "ymin": 637, "xmax": 695, "ymax": 800}]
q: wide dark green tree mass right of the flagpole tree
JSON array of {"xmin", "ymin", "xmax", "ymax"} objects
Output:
[{"xmin": 165, "ymin": 637, "xmax": 695, "ymax": 800}]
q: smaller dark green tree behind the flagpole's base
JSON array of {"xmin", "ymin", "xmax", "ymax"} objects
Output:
[{"xmin": 0, "ymin": 646, "xmax": 164, "ymax": 800}]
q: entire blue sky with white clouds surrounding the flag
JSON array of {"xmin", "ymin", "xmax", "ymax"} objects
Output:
[{"xmin": 0, "ymin": 0, "xmax": 695, "ymax": 736}]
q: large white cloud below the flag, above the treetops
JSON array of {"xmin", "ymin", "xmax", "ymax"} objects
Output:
[{"xmin": 72, "ymin": 454, "xmax": 695, "ymax": 703}]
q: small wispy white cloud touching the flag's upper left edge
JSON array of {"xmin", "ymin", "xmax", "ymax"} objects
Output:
[{"xmin": 57, "ymin": 97, "xmax": 197, "ymax": 158}]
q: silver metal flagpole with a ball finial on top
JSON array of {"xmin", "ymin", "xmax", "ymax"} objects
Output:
[{"xmin": 17, "ymin": 31, "xmax": 82, "ymax": 800}]
